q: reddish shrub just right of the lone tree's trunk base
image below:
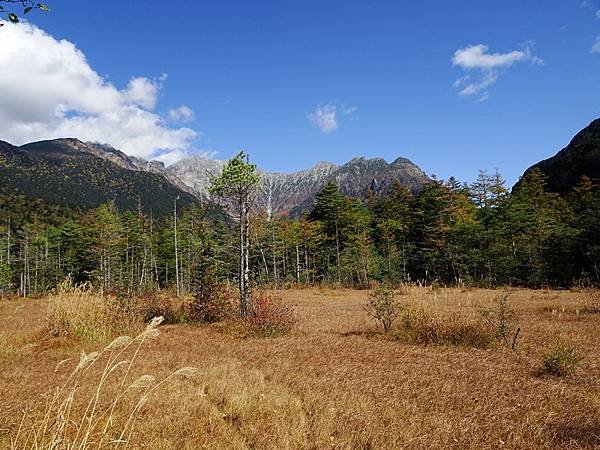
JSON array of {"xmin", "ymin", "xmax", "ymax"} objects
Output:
[{"xmin": 243, "ymin": 292, "xmax": 296, "ymax": 337}]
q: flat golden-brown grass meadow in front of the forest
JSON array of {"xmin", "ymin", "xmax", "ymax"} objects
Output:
[{"xmin": 0, "ymin": 287, "xmax": 600, "ymax": 449}]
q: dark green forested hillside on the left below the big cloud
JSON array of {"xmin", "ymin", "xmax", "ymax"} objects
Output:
[{"xmin": 0, "ymin": 139, "xmax": 199, "ymax": 217}]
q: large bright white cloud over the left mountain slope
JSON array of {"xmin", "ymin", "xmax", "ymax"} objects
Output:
[{"xmin": 0, "ymin": 23, "xmax": 198, "ymax": 163}]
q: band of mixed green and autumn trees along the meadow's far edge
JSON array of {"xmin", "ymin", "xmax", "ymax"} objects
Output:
[{"xmin": 0, "ymin": 163, "xmax": 600, "ymax": 298}]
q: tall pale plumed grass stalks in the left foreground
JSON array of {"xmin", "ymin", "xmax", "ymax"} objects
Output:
[{"xmin": 10, "ymin": 317, "xmax": 196, "ymax": 450}]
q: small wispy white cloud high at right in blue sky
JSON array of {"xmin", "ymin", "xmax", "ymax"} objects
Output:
[{"xmin": 452, "ymin": 42, "xmax": 544, "ymax": 101}]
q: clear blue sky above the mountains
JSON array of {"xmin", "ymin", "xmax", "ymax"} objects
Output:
[{"xmin": 0, "ymin": 0, "xmax": 600, "ymax": 183}]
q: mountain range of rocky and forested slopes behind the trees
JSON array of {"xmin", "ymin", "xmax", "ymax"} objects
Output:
[{"xmin": 0, "ymin": 119, "xmax": 600, "ymax": 217}]
